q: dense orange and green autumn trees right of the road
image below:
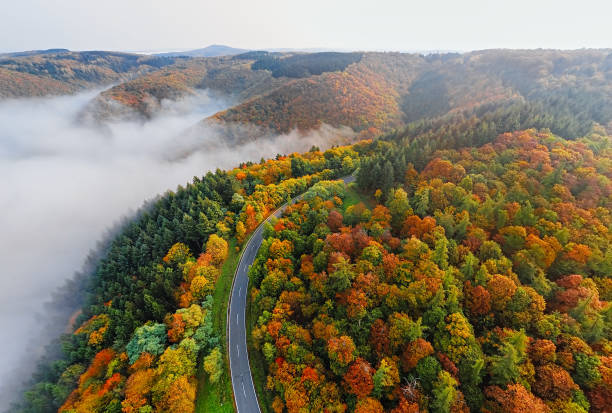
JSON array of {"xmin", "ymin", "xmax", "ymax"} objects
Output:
[{"xmin": 250, "ymin": 130, "xmax": 612, "ymax": 412}]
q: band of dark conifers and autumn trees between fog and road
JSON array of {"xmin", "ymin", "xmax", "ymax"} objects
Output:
[{"xmin": 13, "ymin": 148, "xmax": 366, "ymax": 412}]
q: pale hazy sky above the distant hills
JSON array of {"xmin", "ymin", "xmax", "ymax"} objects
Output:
[{"xmin": 0, "ymin": 0, "xmax": 612, "ymax": 51}]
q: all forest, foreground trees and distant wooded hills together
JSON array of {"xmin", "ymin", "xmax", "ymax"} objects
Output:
[{"xmin": 7, "ymin": 51, "xmax": 612, "ymax": 413}]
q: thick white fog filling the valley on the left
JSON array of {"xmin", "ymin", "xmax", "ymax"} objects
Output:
[{"xmin": 0, "ymin": 91, "xmax": 346, "ymax": 411}]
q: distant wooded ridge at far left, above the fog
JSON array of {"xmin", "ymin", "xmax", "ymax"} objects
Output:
[{"xmin": 0, "ymin": 49, "xmax": 176, "ymax": 99}]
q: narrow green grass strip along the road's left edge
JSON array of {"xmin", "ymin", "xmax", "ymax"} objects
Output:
[{"xmin": 195, "ymin": 238, "xmax": 241, "ymax": 413}]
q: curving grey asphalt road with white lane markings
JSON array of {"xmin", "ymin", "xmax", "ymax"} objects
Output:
[{"xmin": 227, "ymin": 176, "xmax": 355, "ymax": 413}]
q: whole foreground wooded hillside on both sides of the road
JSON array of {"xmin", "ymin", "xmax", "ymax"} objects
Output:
[{"xmin": 12, "ymin": 91, "xmax": 612, "ymax": 413}]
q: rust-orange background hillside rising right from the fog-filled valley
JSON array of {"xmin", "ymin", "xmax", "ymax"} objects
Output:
[{"xmin": 215, "ymin": 50, "xmax": 612, "ymax": 135}]
